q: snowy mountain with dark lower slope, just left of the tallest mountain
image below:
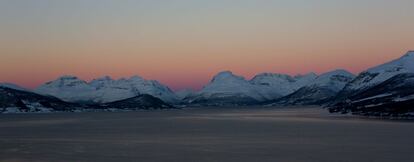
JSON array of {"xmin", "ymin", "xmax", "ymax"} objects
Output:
[{"xmin": 274, "ymin": 70, "xmax": 355, "ymax": 105}]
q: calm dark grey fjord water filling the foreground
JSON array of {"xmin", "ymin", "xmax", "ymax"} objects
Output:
[{"xmin": 0, "ymin": 108, "xmax": 414, "ymax": 162}]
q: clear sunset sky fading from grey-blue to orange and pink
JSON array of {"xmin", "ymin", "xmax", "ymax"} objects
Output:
[{"xmin": 0, "ymin": 0, "xmax": 414, "ymax": 90}]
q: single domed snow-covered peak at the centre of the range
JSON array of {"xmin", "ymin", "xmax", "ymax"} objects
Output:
[{"xmin": 185, "ymin": 71, "xmax": 266, "ymax": 105}]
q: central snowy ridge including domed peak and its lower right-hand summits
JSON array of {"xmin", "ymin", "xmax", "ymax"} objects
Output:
[{"xmin": 185, "ymin": 71, "xmax": 317, "ymax": 105}]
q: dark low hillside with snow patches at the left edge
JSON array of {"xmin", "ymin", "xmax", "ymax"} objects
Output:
[{"xmin": 0, "ymin": 87, "xmax": 82, "ymax": 113}]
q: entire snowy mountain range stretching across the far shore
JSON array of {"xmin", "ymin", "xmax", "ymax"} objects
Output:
[{"xmin": 0, "ymin": 51, "xmax": 414, "ymax": 116}]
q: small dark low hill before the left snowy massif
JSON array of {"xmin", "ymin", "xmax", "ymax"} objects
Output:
[{"xmin": 102, "ymin": 94, "xmax": 174, "ymax": 109}]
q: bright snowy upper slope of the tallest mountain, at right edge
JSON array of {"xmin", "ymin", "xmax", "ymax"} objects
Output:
[{"xmin": 342, "ymin": 51, "xmax": 414, "ymax": 95}]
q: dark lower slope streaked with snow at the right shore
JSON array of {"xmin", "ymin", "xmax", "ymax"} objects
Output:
[{"xmin": 329, "ymin": 73, "xmax": 414, "ymax": 116}]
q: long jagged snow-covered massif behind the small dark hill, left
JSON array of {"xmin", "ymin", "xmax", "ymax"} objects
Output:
[{"xmin": 35, "ymin": 76, "xmax": 178, "ymax": 103}]
